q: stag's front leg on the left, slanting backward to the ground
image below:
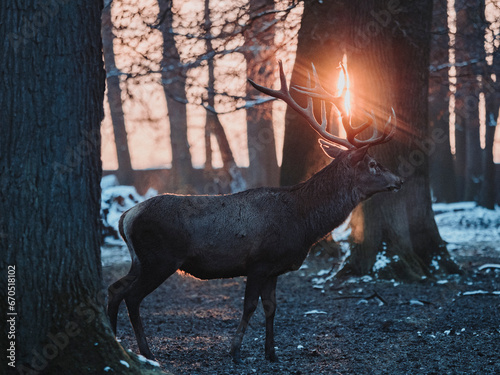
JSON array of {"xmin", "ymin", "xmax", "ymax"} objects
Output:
[{"xmin": 230, "ymin": 275, "xmax": 262, "ymax": 364}]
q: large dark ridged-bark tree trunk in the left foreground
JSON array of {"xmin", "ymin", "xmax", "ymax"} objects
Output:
[{"xmin": 0, "ymin": 0, "xmax": 166, "ymax": 374}]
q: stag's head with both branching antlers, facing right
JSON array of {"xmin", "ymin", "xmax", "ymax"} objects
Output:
[{"xmin": 248, "ymin": 61, "xmax": 403, "ymax": 199}]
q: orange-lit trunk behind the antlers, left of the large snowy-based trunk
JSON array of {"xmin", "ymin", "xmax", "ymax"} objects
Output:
[{"xmin": 280, "ymin": 0, "xmax": 349, "ymax": 186}]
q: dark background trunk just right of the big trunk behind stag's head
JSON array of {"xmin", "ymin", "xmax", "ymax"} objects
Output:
[{"xmin": 427, "ymin": 0, "xmax": 457, "ymax": 202}]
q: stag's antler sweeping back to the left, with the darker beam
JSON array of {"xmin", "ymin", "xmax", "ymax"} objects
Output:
[{"xmin": 248, "ymin": 61, "xmax": 355, "ymax": 149}]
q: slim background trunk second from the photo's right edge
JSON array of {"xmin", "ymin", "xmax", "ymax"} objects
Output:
[{"xmin": 455, "ymin": 0, "xmax": 485, "ymax": 201}]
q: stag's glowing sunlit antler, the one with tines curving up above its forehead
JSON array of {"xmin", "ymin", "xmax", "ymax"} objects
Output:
[{"xmin": 293, "ymin": 63, "xmax": 397, "ymax": 148}]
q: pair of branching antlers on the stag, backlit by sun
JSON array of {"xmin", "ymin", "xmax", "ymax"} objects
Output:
[{"xmin": 248, "ymin": 61, "xmax": 396, "ymax": 149}]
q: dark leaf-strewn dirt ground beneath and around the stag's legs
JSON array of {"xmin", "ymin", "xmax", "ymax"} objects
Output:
[{"xmin": 104, "ymin": 244, "xmax": 500, "ymax": 375}]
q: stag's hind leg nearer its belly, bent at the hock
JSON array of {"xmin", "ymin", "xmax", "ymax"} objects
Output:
[{"xmin": 125, "ymin": 265, "xmax": 178, "ymax": 359}]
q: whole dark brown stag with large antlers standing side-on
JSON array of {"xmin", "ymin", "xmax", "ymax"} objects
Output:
[{"xmin": 107, "ymin": 61, "xmax": 403, "ymax": 364}]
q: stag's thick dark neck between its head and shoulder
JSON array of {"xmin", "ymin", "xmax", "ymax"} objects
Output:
[{"xmin": 297, "ymin": 159, "xmax": 361, "ymax": 242}]
